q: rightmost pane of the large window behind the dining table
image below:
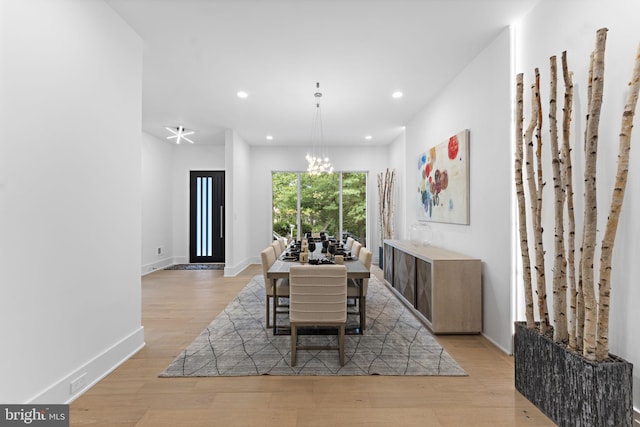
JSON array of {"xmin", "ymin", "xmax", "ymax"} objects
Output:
[{"xmin": 342, "ymin": 172, "xmax": 367, "ymax": 245}]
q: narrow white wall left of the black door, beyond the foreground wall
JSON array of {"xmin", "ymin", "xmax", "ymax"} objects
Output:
[{"xmin": 141, "ymin": 132, "xmax": 175, "ymax": 274}]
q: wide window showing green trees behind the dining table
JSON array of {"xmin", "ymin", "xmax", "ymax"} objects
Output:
[{"xmin": 271, "ymin": 172, "xmax": 367, "ymax": 244}]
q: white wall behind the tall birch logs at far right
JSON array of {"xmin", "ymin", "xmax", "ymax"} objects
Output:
[{"xmin": 516, "ymin": 0, "xmax": 640, "ymax": 407}]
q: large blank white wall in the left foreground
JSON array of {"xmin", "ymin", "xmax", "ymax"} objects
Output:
[{"xmin": 0, "ymin": 0, "xmax": 144, "ymax": 403}]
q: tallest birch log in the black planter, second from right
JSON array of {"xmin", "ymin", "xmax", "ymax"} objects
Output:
[{"xmin": 582, "ymin": 28, "xmax": 607, "ymax": 360}]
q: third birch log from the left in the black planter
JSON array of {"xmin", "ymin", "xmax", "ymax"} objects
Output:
[{"xmin": 549, "ymin": 56, "xmax": 569, "ymax": 342}]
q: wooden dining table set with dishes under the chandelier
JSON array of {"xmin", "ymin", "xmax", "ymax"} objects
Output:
[{"xmin": 267, "ymin": 251, "xmax": 371, "ymax": 335}]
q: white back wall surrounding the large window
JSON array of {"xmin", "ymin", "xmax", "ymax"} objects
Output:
[{"xmin": 250, "ymin": 146, "xmax": 389, "ymax": 263}]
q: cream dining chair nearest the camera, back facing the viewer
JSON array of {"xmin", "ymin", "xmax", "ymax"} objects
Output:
[{"xmin": 289, "ymin": 265, "xmax": 347, "ymax": 366}]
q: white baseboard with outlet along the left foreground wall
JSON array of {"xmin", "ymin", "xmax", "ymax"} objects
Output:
[{"xmin": 27, "ymin": 326, "xmax": 145, "ymax": 404}]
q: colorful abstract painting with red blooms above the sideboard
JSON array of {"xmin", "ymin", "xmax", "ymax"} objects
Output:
[{"xmin": 416, "ymin": 129, "xmax": 469, "ymax": 224}]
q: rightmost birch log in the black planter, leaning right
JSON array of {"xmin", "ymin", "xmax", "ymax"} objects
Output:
[{"xmin": 596, "ymin": 41, "xmax": 640, "ymax": 361}]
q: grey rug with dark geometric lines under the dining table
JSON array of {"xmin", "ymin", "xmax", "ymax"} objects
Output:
[{"xmin": 160, "ymin": 276, "xmax": 467, "ymax": 377}]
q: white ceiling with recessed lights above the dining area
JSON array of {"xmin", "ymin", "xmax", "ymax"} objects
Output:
[{"xmin": 106, "ymin": 0, "xmax": 539, "ymax": 145}]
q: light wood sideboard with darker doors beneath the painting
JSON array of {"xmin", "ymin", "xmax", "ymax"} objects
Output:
[{"xmin": 383, "ymin": 240, "xmax": 482, "ymax": 334}]
